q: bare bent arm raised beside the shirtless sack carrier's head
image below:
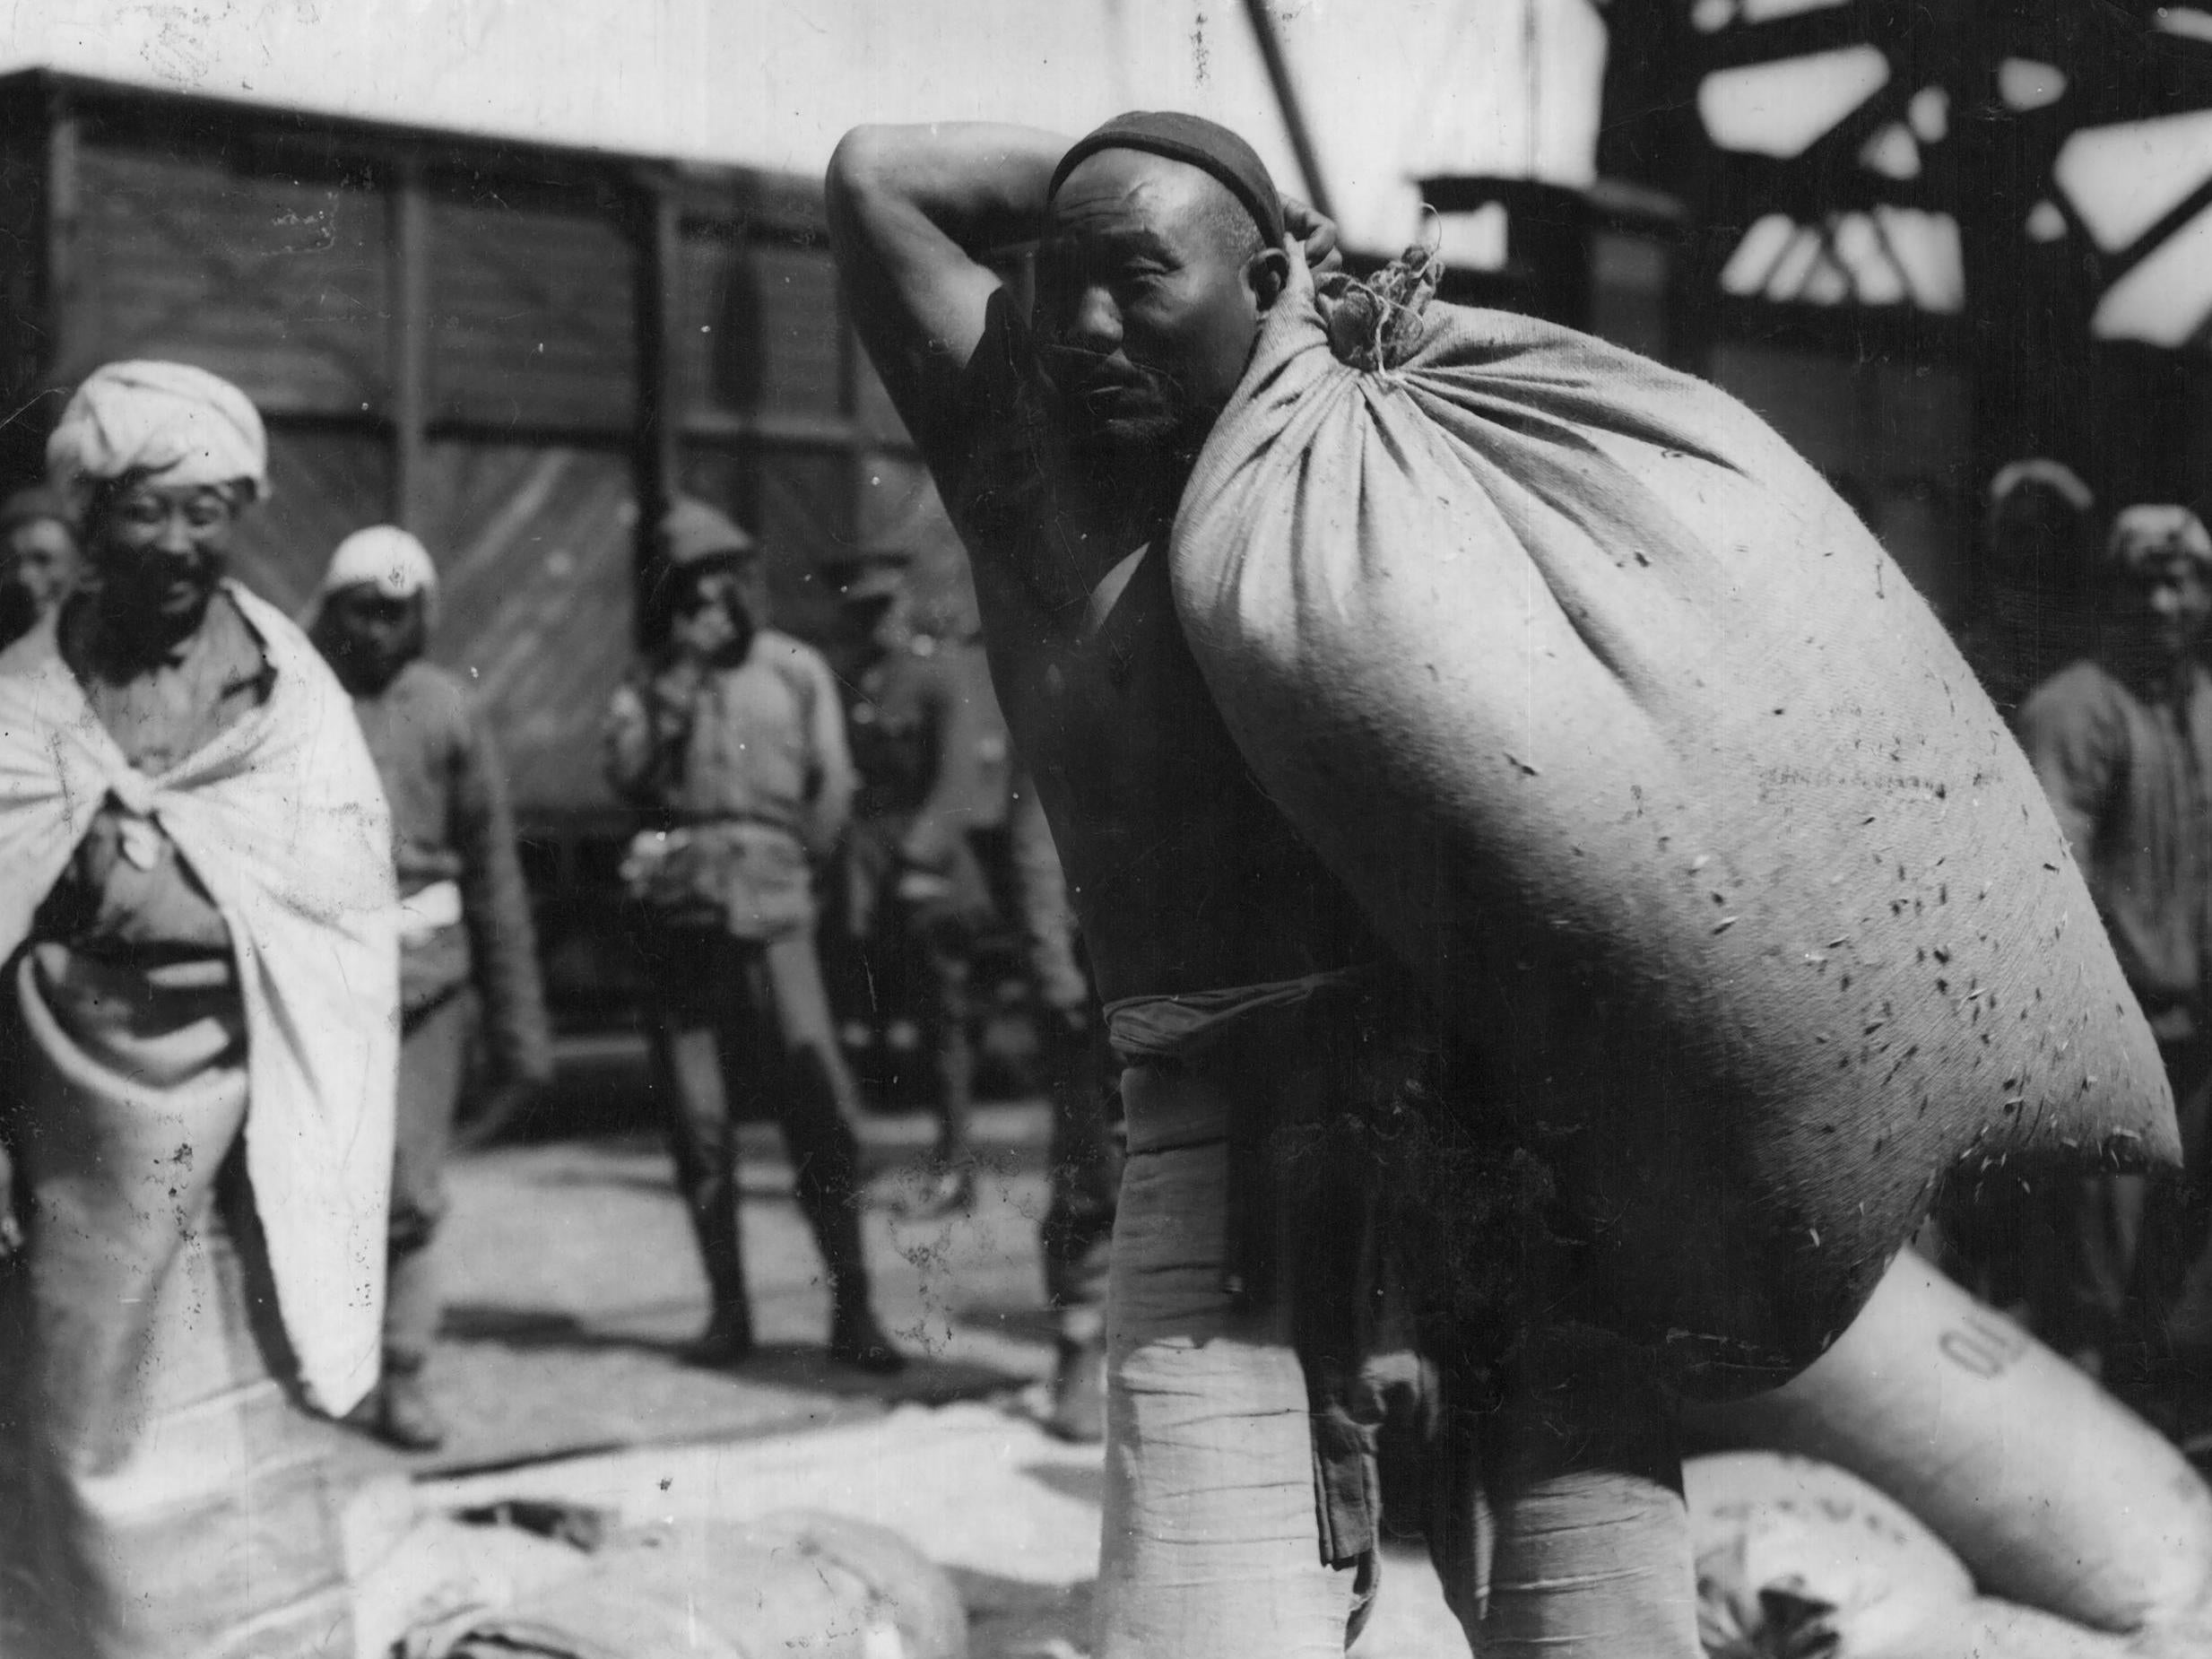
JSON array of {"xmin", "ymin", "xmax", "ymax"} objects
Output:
[{"xmin": 828, "ymin": 122, "xmax": 1072, "ymax": 465}]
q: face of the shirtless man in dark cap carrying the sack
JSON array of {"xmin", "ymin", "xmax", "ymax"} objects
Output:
[{"xmin": 1036, "ymin": 151, "xmax": 1280, "ymax": 462}]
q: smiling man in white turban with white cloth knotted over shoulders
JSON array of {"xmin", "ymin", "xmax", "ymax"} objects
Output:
[{"xmin": 0, "ymin": 363, "xmax": 398, "ymax": 1659}]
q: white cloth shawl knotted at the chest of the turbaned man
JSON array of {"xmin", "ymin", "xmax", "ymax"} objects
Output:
[{"xmin": 0, "ymin": 584, "xmax": 398, "ymax": 1416}]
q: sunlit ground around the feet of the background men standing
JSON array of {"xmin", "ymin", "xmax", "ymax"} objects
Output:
[{"xmin": 343, "ymin": 1106, "xmax": 1053, "ymax": 1473}]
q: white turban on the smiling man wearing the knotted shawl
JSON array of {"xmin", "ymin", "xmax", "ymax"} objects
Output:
[{"xmin": 47, "ymin": 363, "xmax": 270, "ymax": 513}]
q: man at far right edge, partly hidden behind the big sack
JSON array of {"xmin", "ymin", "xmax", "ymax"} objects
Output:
[{"xmin": 2019, "ymin": 507, "xmax": 2212, "ymax": 1387}]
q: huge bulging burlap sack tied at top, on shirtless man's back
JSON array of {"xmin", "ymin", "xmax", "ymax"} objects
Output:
[{"xmin": 1170, "ymin": 247, "xmax": 2177, "ymax": 1387}]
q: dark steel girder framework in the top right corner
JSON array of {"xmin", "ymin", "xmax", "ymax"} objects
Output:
[{"xmin": 1597, "ymin": 0, "xmax": 2212, "ymax": 506}]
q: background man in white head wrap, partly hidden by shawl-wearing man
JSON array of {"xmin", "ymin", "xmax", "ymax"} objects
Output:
[{"xmin": 312, "ymin": 525, "xmax": 553, "ymax": 1451}]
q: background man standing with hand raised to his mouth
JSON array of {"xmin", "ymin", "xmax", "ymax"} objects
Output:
[{"xmin": 606, "ymin": 499, "xmax": 905, "ymax": 1371}]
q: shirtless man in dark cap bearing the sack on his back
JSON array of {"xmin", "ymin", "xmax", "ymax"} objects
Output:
[{"xmin": 829, "ymin": 117, "xmax": 1451, "ymax": 1659}]
